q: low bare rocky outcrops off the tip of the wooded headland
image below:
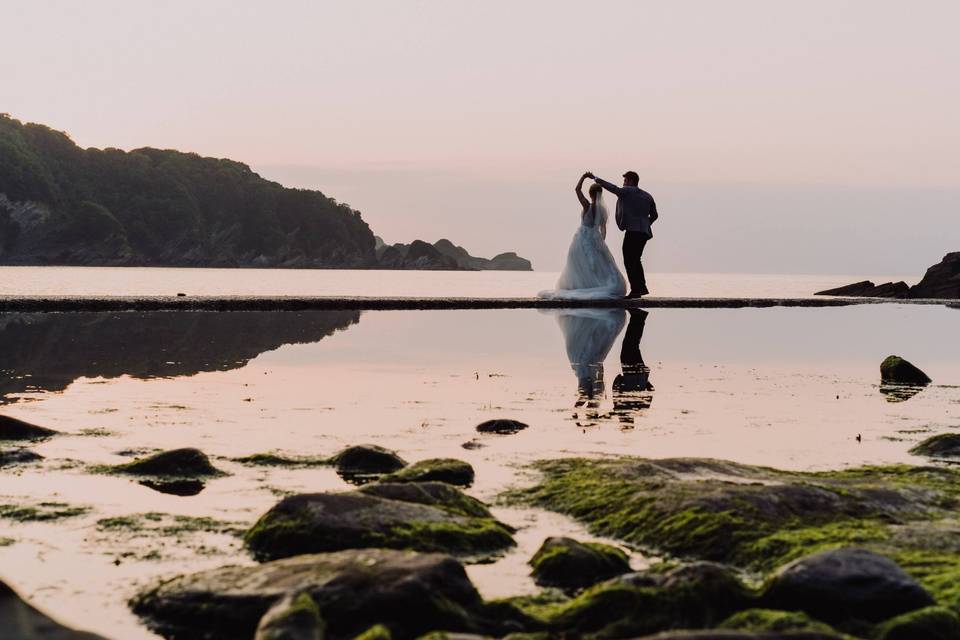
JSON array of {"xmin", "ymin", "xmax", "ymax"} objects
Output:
[{"xmin": 376, "ymin": 237, "xmax": 533, "ymax": 271}]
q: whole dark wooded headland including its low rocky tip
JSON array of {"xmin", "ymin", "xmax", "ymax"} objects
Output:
[{"xmin": 0, "ymin": 114, "xmax": 529, "ymax": 269}]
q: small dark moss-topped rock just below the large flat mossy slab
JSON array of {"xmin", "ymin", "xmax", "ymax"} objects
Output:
[{"xmin": 529, "ymin": 537, "xmax": 630, "ymax": 589}]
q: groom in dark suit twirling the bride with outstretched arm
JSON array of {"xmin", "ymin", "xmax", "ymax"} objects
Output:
[{"xmin": 587, "ymin": 171, "xmax": 659, "ymax": 298}]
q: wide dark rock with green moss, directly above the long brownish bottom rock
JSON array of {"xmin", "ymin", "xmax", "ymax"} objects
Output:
[{"xmin": 244, "ymin": 492, "xmax": 514, "ymax": 560}]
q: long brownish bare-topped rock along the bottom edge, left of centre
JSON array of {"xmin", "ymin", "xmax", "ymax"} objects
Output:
[{"xmin": 131, "ymin": 549, "xmax": 518, "ymax": 640}]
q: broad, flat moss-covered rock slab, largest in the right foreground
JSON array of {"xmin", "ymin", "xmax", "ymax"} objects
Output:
[{"xmin": 505, "ymin": 457, "xmax": 960, "ymax": 606}]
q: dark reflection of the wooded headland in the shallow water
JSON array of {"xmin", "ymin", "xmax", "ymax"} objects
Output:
[{"xmin": 0, "ymin": 311, "xmax": 360, "ymax": 404}]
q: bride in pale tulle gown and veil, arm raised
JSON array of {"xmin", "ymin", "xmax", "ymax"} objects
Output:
[{"xmin": 539, "ymin": 174, "xmax": 627, "ymax": 300}]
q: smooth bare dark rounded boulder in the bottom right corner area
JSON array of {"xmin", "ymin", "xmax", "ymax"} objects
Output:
[{"xmin": 764, "ymin": 547, "xmax": 933, "ymax": 622}]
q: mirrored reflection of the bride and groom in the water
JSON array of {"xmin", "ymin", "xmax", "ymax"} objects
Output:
[{"xmin": 557, "ymin": 309, "xmax": 653, "ymax": 429}]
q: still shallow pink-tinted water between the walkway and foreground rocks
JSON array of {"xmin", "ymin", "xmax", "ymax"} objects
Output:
[{"xmin": 0, "ymin": 305, "xmax": 960, "ymax": 638}]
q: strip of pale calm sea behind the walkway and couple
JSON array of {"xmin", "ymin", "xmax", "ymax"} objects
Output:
[{"xmin": 0, "ymin": 267, "xmax": 916, "ymax": 298}]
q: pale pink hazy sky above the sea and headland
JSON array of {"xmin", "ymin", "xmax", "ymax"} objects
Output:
[{"xmin": 0, "ymin": 0, "xmax": 960, "ymax": 276}]
